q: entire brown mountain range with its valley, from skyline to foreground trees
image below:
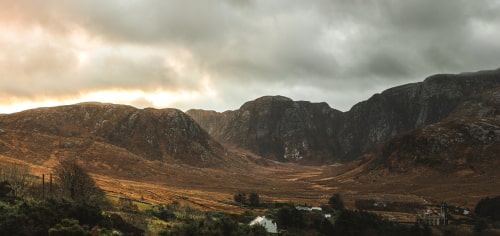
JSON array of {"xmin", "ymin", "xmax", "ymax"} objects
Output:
[{"xmin": 0, "ymin": 69, "xmax": 500, "ymax": 210}]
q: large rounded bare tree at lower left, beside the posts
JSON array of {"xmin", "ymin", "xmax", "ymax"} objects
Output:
[{"xmin": 55, "ymin": 160, "xmax": 104, "ymax": 205}]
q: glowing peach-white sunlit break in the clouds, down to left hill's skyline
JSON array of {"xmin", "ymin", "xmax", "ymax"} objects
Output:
[{"xmin": 0, "ymin": 20, "xmax": 216, "ymax": 113}]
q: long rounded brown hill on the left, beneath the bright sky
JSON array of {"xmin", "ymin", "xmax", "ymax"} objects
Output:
[{"xmin": 0, "ymin": 103, "xmax": 222, "ymax": 165}]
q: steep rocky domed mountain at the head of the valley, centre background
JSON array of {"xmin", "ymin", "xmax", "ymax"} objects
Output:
[{"xmin": 187, "ymin": 96, "xmax": 342, "ymax": 163}]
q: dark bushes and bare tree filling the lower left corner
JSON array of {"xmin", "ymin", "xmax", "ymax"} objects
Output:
[{"xmin": 0, "ymin": 161, "xmax": 144, "ymax": 236}]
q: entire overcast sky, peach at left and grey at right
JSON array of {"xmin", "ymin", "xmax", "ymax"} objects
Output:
[{"xmin": 0, "ymin": 0, "xmax": 500, "ymax": 113}]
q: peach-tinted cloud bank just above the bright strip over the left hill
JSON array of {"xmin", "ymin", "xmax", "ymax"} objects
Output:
[{"xmin": 0, "ymin": 34, "xmax": 200, "ymax": 99}]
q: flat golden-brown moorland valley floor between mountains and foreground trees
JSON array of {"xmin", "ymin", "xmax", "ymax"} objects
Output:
[{"xmin": 0, "ymin": 148, "xmax": 500, "ymax": 219}]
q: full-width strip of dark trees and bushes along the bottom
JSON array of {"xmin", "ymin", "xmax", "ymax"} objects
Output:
[{"xmin": 0, "ymin": 161, "xmax": 500, "ymax": 236}]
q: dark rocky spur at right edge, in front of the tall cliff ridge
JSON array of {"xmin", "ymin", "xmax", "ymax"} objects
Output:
[{"xmin": 373, "ymin": 87, "xmax": 500, "ymax": 173}]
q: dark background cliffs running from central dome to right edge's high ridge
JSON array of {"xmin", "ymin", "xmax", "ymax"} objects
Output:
[{"xmin": 187, "ymin": 70, "xmax": 500, "ymax": 164}]
